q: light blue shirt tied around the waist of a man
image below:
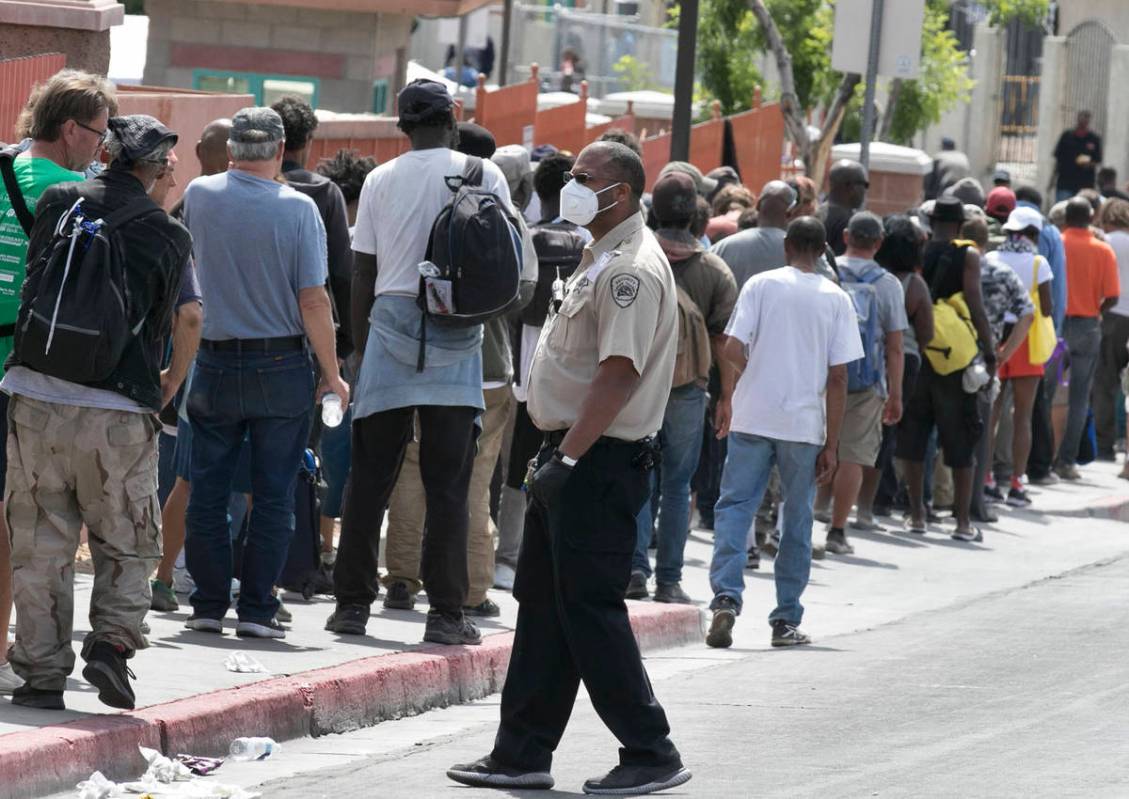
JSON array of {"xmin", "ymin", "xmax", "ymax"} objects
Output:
[{"xmin": 352, "ymin": 295, "xmax": 485, "ymax": 419}]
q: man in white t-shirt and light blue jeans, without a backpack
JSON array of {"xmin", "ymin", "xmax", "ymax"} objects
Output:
[{"xmin": 706, "ymin": 217, "xmax": 863, "ymax": 647}]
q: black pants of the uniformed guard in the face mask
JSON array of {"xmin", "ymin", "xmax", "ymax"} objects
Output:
[{"xmin": 492, "ymin": 439, "xmax": 681, "ymax": 771}]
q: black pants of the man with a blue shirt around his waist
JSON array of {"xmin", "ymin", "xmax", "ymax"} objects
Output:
[{"xmin": 333, "ymin": 405, "xmax": 479, "ymax": 614}]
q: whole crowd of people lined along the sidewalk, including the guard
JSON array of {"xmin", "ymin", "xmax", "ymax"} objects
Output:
[{"xmin": 0, "ymin": 70, "xmax": 1129, "ymax": 758}]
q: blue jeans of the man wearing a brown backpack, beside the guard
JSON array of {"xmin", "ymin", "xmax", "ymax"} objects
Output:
[{"xmin": 631, "ymin": 384, "xmax": 708, "ymax": 586}]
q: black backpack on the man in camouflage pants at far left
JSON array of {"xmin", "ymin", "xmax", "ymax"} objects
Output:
[{"xmin": 15, "ymin": 192, "xmax": 164, "ymax": 384}]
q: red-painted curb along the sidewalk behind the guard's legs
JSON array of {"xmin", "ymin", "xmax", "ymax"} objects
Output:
[{"xmin": 0, "ymin": 603, "xmax": 701, "ymax": 799}]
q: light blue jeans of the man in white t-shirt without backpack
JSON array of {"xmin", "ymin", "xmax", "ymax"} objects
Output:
[{"xmin": 709, "ymin": 432, "xmax": 821, "ymax": 624}]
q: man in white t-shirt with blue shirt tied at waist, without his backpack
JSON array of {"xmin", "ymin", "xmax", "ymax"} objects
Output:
[{"xmin": 325, "ymin": 80, "xmax": 510, "ymax": 644}]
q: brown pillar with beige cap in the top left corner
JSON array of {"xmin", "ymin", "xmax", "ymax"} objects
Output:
[{"xmin": 0, "ymin": 0, "xmax": 125, "ymax": 74}]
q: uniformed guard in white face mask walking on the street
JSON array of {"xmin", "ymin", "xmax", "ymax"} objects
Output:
[{"xmin": 447, "ymin": 142, "xmax": 690, "ymax": 796}]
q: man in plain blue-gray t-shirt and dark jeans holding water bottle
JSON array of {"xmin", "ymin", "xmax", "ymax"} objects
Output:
[{"xmin": 184, "ymin": 108, "xmax": 349, "ymax": 638}]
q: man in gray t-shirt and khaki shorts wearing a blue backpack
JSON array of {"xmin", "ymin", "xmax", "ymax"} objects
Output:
[{"xmin": 815, "ymin": 211, "xmax": 909, "ymax": 554}]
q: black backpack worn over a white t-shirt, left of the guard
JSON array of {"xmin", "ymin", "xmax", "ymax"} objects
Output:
[{"xmin": 415, "ymin": 156, "xmax": 522, "ymax": 354}]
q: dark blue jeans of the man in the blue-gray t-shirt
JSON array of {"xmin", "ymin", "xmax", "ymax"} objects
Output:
[{"xmin": 184, "ymin": 350, "xmax": 314, "ymax": 623}]
